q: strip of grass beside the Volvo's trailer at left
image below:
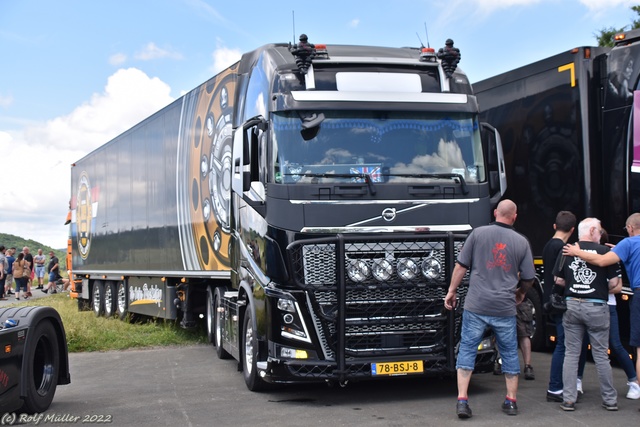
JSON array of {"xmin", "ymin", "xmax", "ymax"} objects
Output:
[{"xmin": 7, "ymin": 293, "xmax": 207, "ymax": 353}]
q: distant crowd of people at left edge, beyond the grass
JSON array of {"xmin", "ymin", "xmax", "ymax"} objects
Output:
[{"xmin": 0, "ymin": 245, "xmax": 69, "ymax": 301}]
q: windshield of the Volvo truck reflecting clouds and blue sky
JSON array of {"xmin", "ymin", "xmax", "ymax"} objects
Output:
[{"xmin": 270, "ymin": 110, "xmax": 485, "ymax": 184}]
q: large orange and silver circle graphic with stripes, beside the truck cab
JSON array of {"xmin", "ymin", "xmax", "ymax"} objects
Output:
[{"xmin": 178, "ymin": 69, "xmax": 236, "ymax": 270}]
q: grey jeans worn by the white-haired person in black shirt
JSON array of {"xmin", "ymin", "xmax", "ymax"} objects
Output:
[{"xmin": 562, "ymin": 299, "xmax": 618, "ymax": 404}]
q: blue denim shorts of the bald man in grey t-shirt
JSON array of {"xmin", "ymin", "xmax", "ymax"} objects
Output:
[{"xmin": 456, "ymin": 310, "xmax": 520, "ymax": 375}]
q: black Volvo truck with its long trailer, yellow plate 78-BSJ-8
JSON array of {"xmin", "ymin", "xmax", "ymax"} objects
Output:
[{"xmin": 70, "ymin": 36, "xmax": 506, "ymax": 390}]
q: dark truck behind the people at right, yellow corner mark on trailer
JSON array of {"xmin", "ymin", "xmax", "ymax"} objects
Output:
[{"xmin": 473, "ymin": 30, "xmax": 640, "ymax": 356}]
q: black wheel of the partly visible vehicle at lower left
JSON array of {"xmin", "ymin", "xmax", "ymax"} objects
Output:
[{"xmin": 22, "ymin": 320, "xmax": 60, "ymax": 413}]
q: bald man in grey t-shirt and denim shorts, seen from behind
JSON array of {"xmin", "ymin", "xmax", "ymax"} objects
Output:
[{"xmin": 444, "ymin": 200, "xmax": 536, "ymax": 418}]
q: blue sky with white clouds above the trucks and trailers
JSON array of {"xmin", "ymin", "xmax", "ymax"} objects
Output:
[{"xmin": 0, "ymin": 0, "xmax": 640, "ymax": 249}]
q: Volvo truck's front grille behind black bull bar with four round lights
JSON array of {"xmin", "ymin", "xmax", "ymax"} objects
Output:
[{"xmin": 289, "ymin": 233, "xmax": 467, "ymax": 360}]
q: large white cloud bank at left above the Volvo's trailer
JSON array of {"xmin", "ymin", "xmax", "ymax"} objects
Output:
[{"xmin": 0, "ymin": 68, "xmax": 173, "ymax": 248}]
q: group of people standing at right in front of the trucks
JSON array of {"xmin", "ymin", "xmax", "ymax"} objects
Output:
[{"xmin": 444, "ymin": 200, "xmax": 640, "ymax": 418}]
